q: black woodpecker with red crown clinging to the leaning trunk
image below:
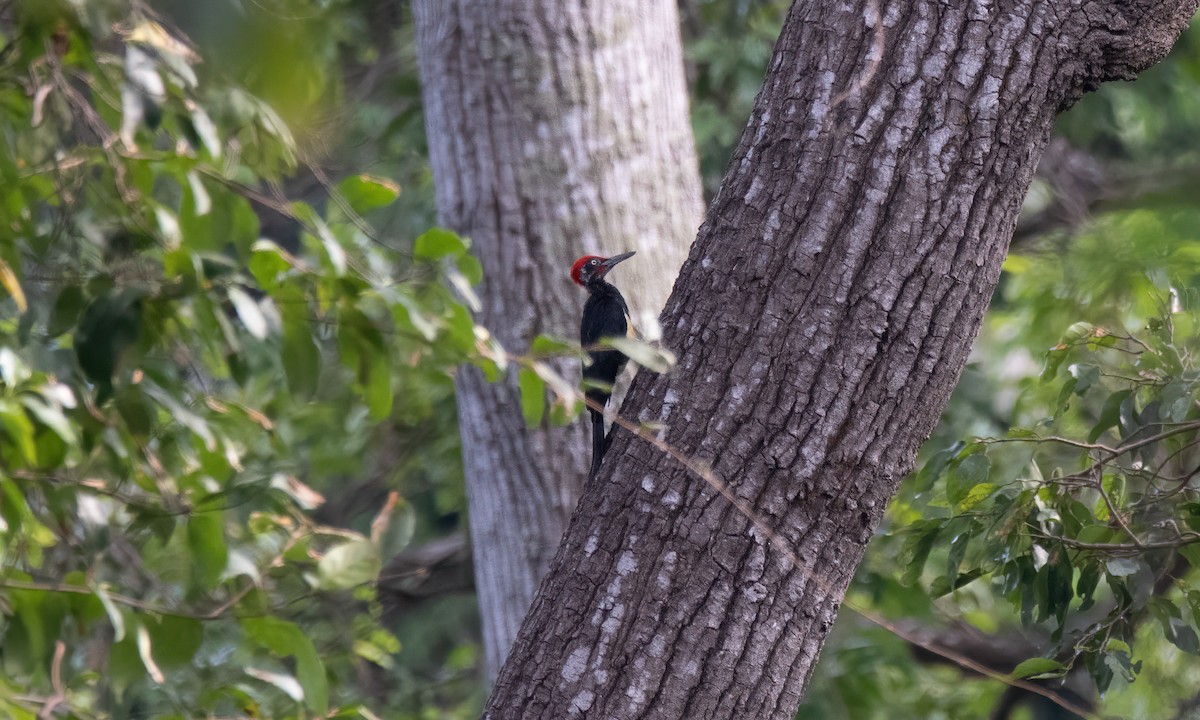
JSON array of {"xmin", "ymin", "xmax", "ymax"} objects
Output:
[{"xmin": 571, "ymin": 252, "xmax": 636, "ymax": 478}]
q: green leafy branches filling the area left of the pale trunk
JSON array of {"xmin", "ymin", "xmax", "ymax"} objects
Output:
[{"xmin": 0, "ymin": 0, "xmax": 496, "ymax": 718}]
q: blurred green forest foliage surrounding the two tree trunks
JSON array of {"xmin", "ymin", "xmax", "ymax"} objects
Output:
[{"xmin": 0, "ymin": 0, "xmax": 1200, "ymax": 720}]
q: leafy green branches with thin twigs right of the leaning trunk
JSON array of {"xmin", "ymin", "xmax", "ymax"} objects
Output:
[{"xmin": 910, "ymin": 307, "xmax": 1200, "ymax": 692}]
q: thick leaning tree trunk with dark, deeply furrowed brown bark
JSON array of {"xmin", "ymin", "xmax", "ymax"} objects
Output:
[{"xmin": 485, "ymin": 0, "xmax": 1195, "ymax": 720}]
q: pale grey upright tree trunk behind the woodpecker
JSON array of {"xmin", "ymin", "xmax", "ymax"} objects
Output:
[{"xmin": 413, "ymin": 0, "xmax": 702, "ymax": 677}]
